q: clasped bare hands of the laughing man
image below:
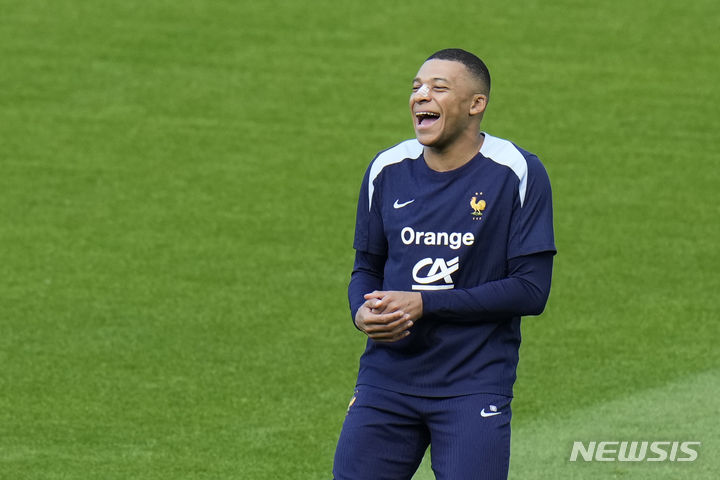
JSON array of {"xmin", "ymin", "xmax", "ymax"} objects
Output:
[{"xmin": 355, "ymin": 290, "xmax": 422, "ymax": 342}]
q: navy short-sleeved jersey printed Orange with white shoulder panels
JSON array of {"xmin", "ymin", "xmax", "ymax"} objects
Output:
[{"xmin": 354, "ymin": 134, "xmax": 555, "ymax": 396}]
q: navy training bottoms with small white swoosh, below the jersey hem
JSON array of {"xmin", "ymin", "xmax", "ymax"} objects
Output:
[{"xmin": 333, "ymin": 385, "xmax": 512, "ymax": 480}]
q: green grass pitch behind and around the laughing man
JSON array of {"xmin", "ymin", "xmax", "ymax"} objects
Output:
[{"xmin": 0, "ymin": 0, "xmax": 720, "ymax": 480}]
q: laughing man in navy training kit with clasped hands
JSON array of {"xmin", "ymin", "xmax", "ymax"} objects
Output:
[{"xmin": 333, "ymin": 49, "xmax": 555, "ymax": 480}]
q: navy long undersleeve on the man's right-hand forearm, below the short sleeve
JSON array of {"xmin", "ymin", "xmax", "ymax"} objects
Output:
[{"xmin": 422, "ymin": 252, "xmax": 553, "ymax": 320}]
